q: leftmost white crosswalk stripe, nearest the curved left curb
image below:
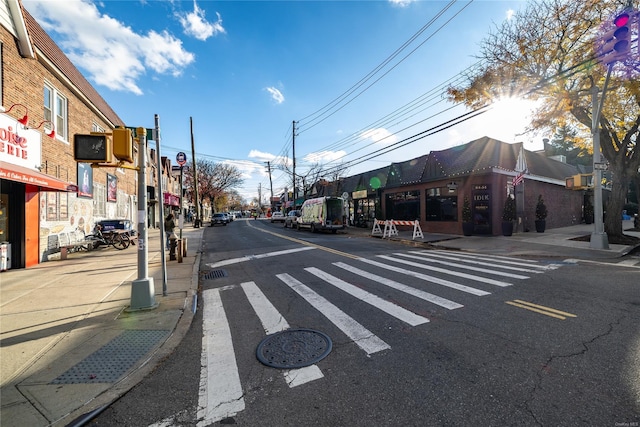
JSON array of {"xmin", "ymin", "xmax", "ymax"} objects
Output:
[{"xmin": 197, "ymin": 289, "xmax": 244, "ymax": 427}]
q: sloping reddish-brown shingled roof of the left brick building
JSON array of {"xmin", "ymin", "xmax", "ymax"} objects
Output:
[{"xmin": 22, "ymin": 7, "xmax": 125, "ymax": 126}]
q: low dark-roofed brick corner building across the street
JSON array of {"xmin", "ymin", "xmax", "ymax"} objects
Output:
[{"xmin": 332, "ymin": 137, "xmax": 585, "ymax": 236}]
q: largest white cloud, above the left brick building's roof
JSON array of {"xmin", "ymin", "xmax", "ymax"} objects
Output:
[{"xmin": 24, "ymin": 0, "xmax": 195, "ymax": 95}]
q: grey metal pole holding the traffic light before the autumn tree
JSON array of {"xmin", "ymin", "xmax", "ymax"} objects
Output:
[{"xmin": 589, "ymin": 78, "xmax": 612, "ymax": 249}]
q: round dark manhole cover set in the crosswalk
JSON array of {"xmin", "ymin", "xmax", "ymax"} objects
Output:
[{"xmin": 256, "ymin": 329, "xmax": 332, "ymax": 369}]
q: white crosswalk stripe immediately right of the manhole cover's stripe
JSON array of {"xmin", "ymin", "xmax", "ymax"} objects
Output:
[{"xmin": 276, "ymin": 274, "xmax": 391, "ymax": 355}]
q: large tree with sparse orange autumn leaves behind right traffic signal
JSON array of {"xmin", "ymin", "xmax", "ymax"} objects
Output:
[{"xmin": 449, "ymin": 0, "xmax": 640, "ymax": 237}]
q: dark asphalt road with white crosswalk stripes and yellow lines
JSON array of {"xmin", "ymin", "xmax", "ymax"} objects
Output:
[{"xmin": 91, "ymin": 221, "xmax": 640, "ymax": 426}]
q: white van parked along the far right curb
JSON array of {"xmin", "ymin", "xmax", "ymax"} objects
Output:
[{"xmin": 296, "ymin": 197, "xmax": 344, "ymax": 233}]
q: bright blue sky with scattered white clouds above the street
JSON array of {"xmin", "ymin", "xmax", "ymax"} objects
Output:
[{"xmin": 23, "ymin": 0, "xmax": 542, "ymax": 201}]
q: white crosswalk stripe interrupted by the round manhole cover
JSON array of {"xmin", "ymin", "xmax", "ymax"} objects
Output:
[{"xmin": 240, "ymin": 282, "xmax": 324, "ymax": 388}]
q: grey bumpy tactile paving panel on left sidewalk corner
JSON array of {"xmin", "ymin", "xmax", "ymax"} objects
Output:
[{"xmin": 51, "ymin": 330, "xmax": 169, "ymax": 384}]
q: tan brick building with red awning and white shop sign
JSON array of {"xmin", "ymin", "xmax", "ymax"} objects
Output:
[{"xmin": 0, "ymin": 0, "xmax": 141, "ymax": 269}]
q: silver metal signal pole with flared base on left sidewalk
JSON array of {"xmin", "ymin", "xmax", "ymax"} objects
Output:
[{"xmin": 129, "ymin": 128, "xmax": 158, "ymax": 310}]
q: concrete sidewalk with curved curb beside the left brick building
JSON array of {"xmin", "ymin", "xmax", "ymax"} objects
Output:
[{"xmin": 0, "ymin": 228, "xmax": 204, "ymax": 426}]
